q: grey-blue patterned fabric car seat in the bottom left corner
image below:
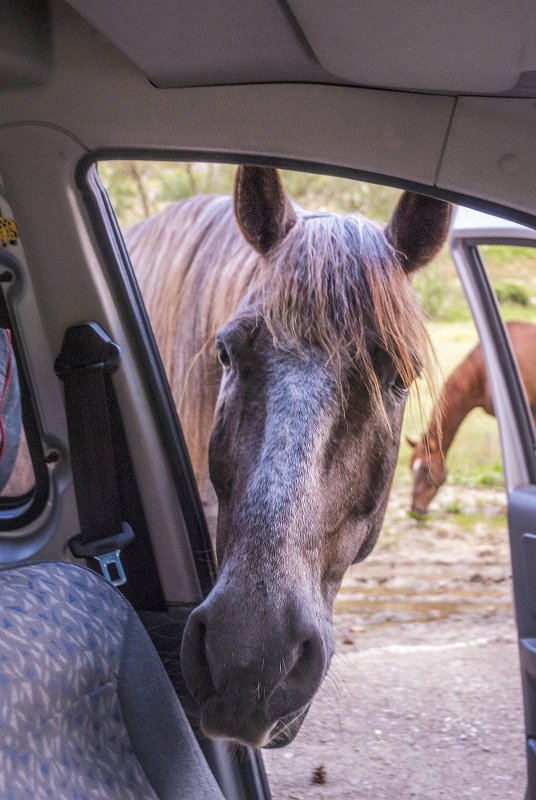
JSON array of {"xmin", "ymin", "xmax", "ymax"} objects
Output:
[{"xmin": 0, "ymin": 563, "xmax": 223, "ymax": 800}]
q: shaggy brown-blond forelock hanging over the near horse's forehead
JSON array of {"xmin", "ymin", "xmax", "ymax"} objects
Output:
[{"xmin": 255, "ymin": 213, "xmax": 429, "ymax": 406}]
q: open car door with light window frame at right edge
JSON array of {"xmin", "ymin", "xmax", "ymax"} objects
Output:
[{"xmin": 450, "ymin": 209, "xmax": 536, "ymax": 800}]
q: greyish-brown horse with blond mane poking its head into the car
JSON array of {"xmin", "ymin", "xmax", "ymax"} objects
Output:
[{"xmin": 126, "ymin": 167, "xmax": 450, "ymax": 747}]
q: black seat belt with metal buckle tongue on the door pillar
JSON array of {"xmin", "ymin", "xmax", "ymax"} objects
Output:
[{"xmin": 54, "ymin": 322, "xmax": 134, "ymax": 586}]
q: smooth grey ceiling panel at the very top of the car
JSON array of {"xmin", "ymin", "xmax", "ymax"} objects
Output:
[{"xmin": 66, "ymin": 0, "xmax": 536, "ymax": 96}]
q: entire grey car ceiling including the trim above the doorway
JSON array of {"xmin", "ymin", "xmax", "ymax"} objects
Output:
[{"xmin": 0, "ymin": 0, "xmax": 536, "ymax": 224}]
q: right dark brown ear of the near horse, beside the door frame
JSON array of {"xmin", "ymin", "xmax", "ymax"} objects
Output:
[{"xmin": 385, "ymin": 192, "xmax": 452, "ymax": 272}]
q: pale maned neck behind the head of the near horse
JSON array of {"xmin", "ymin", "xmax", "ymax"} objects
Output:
[{"xmin": 125, "ymin": 196, "xmax": 258, "ymax": 487}]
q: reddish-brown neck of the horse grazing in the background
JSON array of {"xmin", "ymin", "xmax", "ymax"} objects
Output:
[{"xmin": 427, "ymin": 347, "xmax": 486, "ymax": 454}]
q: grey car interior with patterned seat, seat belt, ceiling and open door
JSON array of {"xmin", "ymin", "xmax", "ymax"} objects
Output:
[{"xmin": 0, "ymin": 0, "xmax": 536, "ymax": 800}]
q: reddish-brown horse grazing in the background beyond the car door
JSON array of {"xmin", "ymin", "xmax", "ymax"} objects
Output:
[{"xmin": 407, "ymin": 322, "xmax": 536, "ymax": 516}]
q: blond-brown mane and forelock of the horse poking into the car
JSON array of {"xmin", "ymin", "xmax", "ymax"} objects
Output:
[{"xmin": 125, "ymin": 195, "xmax": 434, "ymax": 489}]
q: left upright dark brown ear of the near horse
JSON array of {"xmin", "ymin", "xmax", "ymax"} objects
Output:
[{"xmin": 234, "ymin": 167, "xmax": 296, "ymax": 255}]
